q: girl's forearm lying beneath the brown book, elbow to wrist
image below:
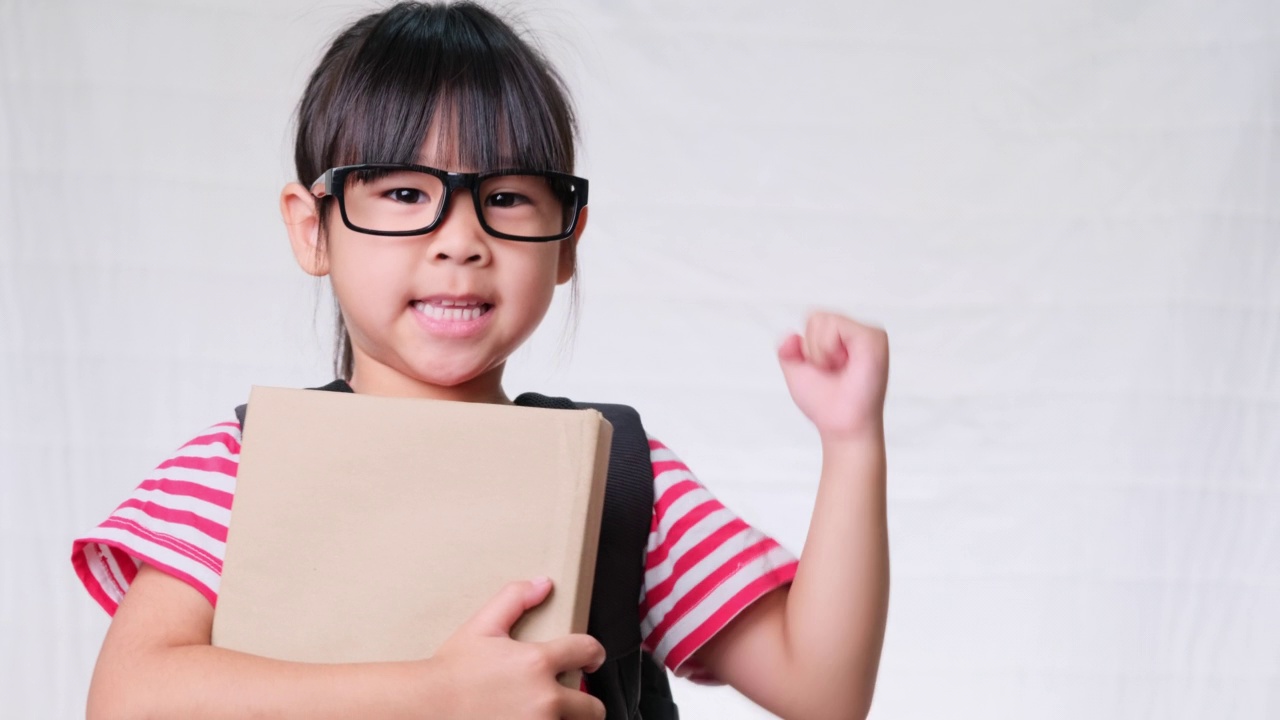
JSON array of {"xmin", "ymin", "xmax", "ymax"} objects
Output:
[{"xmin": 87, "ymin": 646, "xmax": 448, "ymax": 720}]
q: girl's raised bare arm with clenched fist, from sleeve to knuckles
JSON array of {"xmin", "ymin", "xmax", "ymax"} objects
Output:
[{"xmin": 694, "ymin": 314, "xmax": 888, "ymax": 720}]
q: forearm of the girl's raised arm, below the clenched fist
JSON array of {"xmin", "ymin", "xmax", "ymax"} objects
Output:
[{"xmin": 785, "ymin": 425, "xmax": 890, "ymax": 717}]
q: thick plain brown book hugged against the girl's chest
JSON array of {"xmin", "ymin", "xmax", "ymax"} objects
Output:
[{"xmin": 212, "ymin": 387, "xmax": 613, "ymax": 687}]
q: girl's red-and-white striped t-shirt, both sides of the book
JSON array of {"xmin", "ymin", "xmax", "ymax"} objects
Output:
[{"xmin": 72, "ymin": 421, "xmax": 796, "ymax": 682}]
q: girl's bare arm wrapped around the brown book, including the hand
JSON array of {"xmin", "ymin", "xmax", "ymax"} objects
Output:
[{"xmin": 87, "ymin": 565, "xmax": 604, "ymax": 720}]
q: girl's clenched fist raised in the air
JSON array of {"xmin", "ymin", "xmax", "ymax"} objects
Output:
[{"xmin": 778, "ymin": 313, "xmax": 888, "ymax": 442}]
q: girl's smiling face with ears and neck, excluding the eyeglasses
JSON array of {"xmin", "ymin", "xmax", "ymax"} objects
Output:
[{"xmin": 282, "ymin": 138, "xmax": 586, "ymax": 402}]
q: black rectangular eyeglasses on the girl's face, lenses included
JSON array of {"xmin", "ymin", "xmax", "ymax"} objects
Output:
[{"xmin": 311, "ymin": 163, "xmax": 588, "ymax": 242}]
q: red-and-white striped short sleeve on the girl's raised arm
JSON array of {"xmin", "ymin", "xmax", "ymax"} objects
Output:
[{"xmin": 640, "ymin": 438, "xmax": 797, "ymax": 683}]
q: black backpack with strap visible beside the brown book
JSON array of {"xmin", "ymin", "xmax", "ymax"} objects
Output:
[{"xmin": 236, "ymin": 380, "xmax": 680, "ymax": 720}]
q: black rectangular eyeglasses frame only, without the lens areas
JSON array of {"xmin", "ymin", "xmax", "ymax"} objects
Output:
[{"xmin": 310, "ymin": 163, "xmax": 589, "ymax": 242}]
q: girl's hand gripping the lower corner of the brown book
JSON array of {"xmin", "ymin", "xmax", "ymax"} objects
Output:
[{"xmin": 426, "ymin": 579, "xmax": 604, "ymax": 720}]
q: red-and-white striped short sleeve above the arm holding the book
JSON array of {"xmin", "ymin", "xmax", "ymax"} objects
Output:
[{"xmin": 72, "ymin": 423, "xmax": 241, "ymax": 615}]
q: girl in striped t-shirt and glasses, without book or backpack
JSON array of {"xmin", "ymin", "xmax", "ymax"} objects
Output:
[{"xmin": 73, "ymin": 3, "xmax": 888, "ymax": 720}]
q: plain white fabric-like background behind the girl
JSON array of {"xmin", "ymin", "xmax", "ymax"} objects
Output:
[{"xmin": 0, "ymin": 0, "xmax": 1280, "ymax": 720}]
